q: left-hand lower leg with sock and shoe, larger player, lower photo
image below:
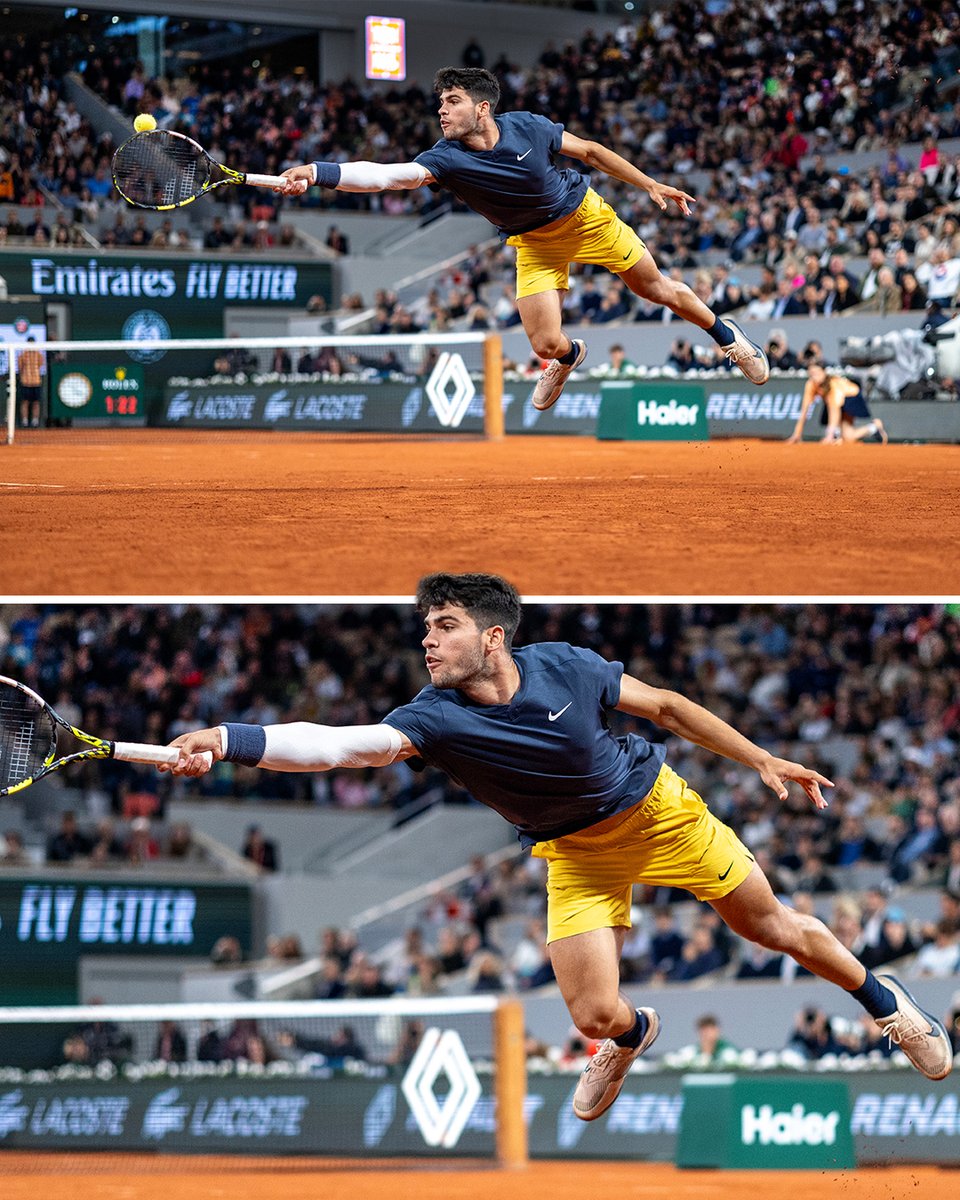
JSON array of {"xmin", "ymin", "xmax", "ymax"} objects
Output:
[{"xmin": 550, "ymin": 926, "xmax": 660, "ymax": 1121}]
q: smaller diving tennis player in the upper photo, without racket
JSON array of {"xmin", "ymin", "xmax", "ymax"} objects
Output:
[{"xmin": 283, "ymin": 67, "xmax": 770, "ymax": 409}]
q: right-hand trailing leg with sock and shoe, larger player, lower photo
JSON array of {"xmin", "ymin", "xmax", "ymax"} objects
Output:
[{"xmin": 710, "ymin": 865, "xmax": 953, "ymax": 1079}]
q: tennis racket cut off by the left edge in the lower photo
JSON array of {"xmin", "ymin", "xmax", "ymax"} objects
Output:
[{"xmin": 0, "ymin": 676, "xmax": 210, "ymax": 796}]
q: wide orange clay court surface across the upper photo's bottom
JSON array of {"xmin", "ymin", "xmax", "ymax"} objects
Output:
[{"xmin": 0, "ymin": 430, "xmax": 960, "ymax": 596}]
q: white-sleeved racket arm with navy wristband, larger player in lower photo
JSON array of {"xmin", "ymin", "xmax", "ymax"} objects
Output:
[{"xmin": 170, "ymin": 721, "xmax": 416, "ymax": 775}]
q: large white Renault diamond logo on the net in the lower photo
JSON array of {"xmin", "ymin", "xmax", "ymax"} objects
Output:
[{"xmin": 401, "ymin": 1028, "xmax": 481, "ymax": 1150}]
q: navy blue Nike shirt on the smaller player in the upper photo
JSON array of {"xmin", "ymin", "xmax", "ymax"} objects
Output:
[{"xmin": 415, "ymin": 113, "xmax": 590, "ymax": 238}]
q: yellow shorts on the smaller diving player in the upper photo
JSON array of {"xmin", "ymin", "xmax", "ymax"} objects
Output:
[{"xmin": 506, "ymin": 187, "xmax": 647, "ymax": 300}]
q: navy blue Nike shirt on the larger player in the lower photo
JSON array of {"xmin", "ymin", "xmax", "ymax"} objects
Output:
[{"xmin": 384, "ymin": 642, "xmax": 666, "ymax": 848}]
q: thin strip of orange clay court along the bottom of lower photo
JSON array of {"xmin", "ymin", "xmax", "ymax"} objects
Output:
[{"xmin": 0, "ymin": 1151, "xmax": 956, "ymax": 1200}]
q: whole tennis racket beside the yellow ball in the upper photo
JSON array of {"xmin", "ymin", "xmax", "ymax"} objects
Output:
[{"xmin": 113, "ymin": 130, "xmax": 287, "ymax": 212}]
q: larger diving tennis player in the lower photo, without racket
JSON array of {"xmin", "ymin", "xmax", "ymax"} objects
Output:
[{"xmin": 172, "ymin": 575, "xmax": 953, "ymax": 1121}]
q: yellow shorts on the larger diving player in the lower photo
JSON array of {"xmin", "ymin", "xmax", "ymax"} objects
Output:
[{"xmin": 530, "ymin": 766, "xmax": 754, "ymax": 942}]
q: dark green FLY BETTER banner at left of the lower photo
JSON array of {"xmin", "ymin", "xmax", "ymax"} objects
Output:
[{"xmin": 0, "ymin": 874, "xmax": 253, "ymax": 1004}]
